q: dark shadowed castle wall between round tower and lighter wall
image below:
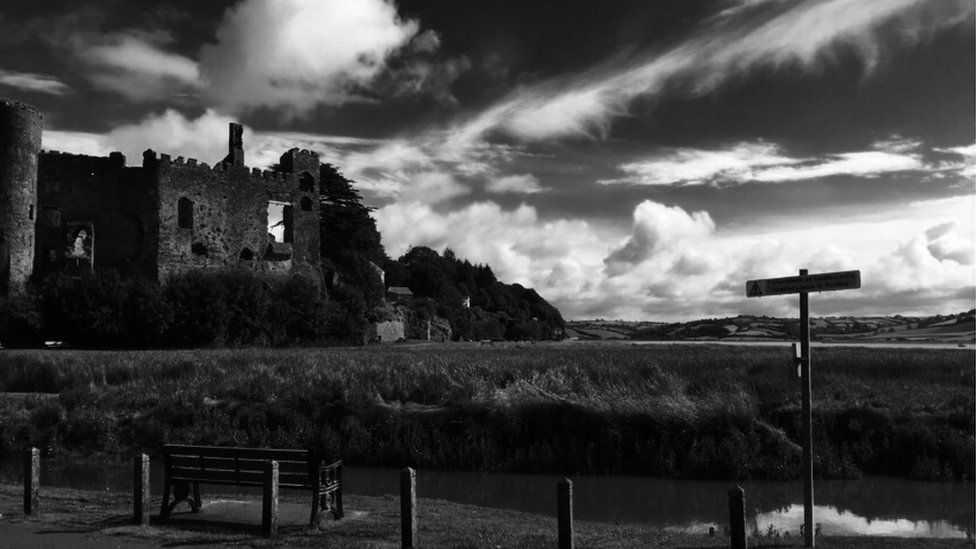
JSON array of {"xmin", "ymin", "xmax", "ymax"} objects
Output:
[{"xmin": 34, "ymin": 152, "xmax": 158, "ymax": 278}]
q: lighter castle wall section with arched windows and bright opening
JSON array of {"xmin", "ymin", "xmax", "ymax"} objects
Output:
[{"xmin": 151, "ymin": 148, "xmax": 320, "ymax": 280}]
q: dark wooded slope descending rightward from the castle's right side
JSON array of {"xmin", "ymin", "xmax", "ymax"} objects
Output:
[{"xmin": 320, "ymin": 164, "xmax": 563, "ymax": 340}]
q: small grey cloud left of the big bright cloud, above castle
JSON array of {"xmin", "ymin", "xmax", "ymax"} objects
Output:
[{"xmin": 77, "ymin": 31, "xmax": 200, "ymax": 101}]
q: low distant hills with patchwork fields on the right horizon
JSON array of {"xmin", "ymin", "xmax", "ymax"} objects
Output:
[{"xmin": 566, "ymin": 311, "xmax": 976, "ymax": 343}]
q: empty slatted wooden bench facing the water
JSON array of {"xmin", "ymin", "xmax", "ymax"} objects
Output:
[{"xmin": 159, "ymin": 444, "xmax": 343, "ymax": 535}]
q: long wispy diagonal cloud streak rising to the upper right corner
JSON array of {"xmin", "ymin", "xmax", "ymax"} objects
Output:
[{"xmin": 455, "ymin": 0, "xmax": 974, "ymax": 141}]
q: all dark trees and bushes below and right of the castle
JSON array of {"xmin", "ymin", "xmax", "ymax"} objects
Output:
[{"xmin": 0, "ymin": 164, "xmax": 563, "ymax": 347}]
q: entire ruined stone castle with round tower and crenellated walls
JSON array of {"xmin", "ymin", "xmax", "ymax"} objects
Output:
[{"xmin": 0, "ymin": 99, "xmax": 321, "ymax": 296}]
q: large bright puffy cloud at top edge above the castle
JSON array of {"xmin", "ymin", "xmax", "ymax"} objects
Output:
[{"xmin": 200, "ymin": 0, "xmax": 422, "ymax": 113}]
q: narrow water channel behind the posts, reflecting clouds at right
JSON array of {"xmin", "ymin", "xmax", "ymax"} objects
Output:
[{"xmin": 0, "ymin": 460, "xmax": 976, "ymax": 537}]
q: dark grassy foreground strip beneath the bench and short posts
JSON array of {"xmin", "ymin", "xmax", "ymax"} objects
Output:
[{"xmin": 0, "ymin": 486, "xmax": 973, "ymax": 549}]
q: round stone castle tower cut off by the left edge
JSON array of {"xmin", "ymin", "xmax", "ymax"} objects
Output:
[{"xmin": 0, "ymin": 98, "xmax": 42, "ymax": 295}]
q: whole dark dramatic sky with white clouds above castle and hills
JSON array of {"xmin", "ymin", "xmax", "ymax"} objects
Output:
[{"xmin": 0, "ymin": 0, "xmax": 976, "ymax": 321}]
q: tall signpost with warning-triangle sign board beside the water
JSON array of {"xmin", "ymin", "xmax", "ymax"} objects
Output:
[{"xmin": 746, "ymin": 269, "xmax": 861, "ymax": 547}]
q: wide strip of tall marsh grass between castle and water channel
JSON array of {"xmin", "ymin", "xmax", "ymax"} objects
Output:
[{"xmin": 0, "ymin": 344, "xmax": 974, "ymax": 480}]
